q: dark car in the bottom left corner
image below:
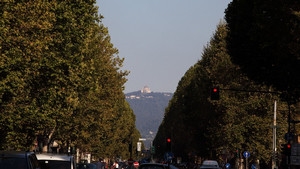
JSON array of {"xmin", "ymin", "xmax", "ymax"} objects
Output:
[{"xmin": 0, "ymin": 151, "xmax": 40, "ymax": 169}]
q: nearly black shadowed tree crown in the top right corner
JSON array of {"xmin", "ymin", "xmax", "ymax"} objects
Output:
[{"xmin": 226, "ymin": 0, "xmax": 300, "ymax": 102}]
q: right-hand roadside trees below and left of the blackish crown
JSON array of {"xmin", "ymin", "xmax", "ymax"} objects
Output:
[{"xmin": 154, "ymin": 23, "xmax": 286, "ymax": 166}]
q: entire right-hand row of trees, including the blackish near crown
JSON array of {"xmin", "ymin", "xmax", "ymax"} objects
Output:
[{"xmin": 154, "ymin": 0, "xmax": 300, "ymax": 168}]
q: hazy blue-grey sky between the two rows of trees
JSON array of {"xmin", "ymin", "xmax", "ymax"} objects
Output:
[{"xmin": 97, "ymin": 0, "xmax": 231, "ymax": 93}]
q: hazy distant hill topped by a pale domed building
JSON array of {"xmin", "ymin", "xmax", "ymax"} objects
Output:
[{"xmin": 125, "ymin": 88, "xmax": 173, "ymax": 148}]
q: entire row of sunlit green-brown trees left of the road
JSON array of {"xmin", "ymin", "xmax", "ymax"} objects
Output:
[{"xmin": 0, "ymin": 0, "xmax": 140, "ymax": 157}]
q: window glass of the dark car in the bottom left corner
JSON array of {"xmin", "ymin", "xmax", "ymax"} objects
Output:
[{"xmin": 0, "ymin": 157, "xmax": 27, "ymax": 169}]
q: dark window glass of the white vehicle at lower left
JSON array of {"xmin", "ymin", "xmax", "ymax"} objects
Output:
[{"xmin": 39, "ymin": 160, "xmax": 71, "ymax": 169}]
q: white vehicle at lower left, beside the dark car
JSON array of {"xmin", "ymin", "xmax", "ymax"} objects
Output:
[{"xmin": 36, "ymin": 154, "xmax": 76, "ymax": 169}]
